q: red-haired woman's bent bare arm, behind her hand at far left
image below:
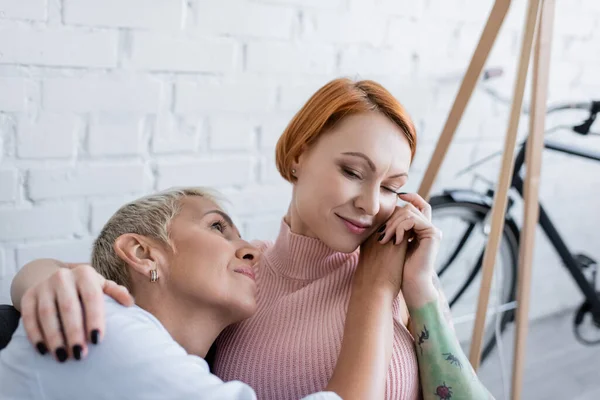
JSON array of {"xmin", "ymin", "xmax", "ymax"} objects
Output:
[{"xmin": 10, "ymin": 258, "xmax": 79, "ymax": 311}]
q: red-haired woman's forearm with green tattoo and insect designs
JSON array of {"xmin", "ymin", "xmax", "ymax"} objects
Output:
[{"xmin": 409, "ymin": 301, "xmax": 491, "ymax": 400}]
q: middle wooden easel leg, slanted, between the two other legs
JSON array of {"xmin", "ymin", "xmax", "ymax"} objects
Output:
[{"xmin": 469, "ymin": 0, "xmax": 541, "ymax": 370}]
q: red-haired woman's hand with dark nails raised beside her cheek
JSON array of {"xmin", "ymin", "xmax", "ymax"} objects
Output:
[{"xmin": 379, "ymin": 193, "xmax": 442, "ymax": 301}]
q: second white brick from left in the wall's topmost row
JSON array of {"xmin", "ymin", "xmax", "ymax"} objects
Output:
[{"xmin": 63, "ymin": 0, "xmax": 184, "ymax": 29}]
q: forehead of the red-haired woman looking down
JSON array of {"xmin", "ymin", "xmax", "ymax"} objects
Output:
[{"xmin": 315, "ymin": 112, "xmax": 411, "ymax": 172}]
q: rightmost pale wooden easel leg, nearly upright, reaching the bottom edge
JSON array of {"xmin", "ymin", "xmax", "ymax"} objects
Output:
[{"xmin": 511, "ymin": 0, "xmax": 554, "ymax": 400}]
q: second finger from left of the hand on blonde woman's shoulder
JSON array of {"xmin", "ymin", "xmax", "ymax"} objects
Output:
[{"xmin": 37, "ymin": 287, "xmax": 68, "ymax": 362}]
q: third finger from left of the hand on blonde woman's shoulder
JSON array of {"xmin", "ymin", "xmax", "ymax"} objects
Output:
[{"xmin": 56, "ymin": 276, "xmax": 86, "ymax": 360}]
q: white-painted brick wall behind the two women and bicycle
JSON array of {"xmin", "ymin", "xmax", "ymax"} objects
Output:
[{"xmin": 0, "ymin": 0, "xmax": 600, "ymax": 322}]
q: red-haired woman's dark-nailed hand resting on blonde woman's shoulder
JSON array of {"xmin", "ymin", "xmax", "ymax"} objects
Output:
[{"xmin": 21, "ymin": 264, "xmax": 133, "ymax": 362}]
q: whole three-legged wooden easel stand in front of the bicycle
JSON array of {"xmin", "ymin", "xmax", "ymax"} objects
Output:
[{"xmin": 419, "ymin": 0, "xmax": 554, "ymax": 400}]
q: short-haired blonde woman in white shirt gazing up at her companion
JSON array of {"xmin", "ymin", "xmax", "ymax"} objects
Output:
[{"xmin": 0, "ymin": 188, "xmax": 408, "ymax": 400}]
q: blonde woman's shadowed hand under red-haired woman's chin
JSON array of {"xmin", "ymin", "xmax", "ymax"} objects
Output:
[{"xmin": 353, "ymin": 225, "xmax": 406, "ymax": 298}]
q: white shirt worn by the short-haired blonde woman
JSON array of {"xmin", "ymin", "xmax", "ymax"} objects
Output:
[{"xmin": 0, "ymin": 296, "xmax": 340, "ymax": 400}]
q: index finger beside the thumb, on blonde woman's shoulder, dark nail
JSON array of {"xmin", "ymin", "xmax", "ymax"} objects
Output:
[{"xmin": 77, "ymin": 269, "xmax": 105, "ymax": 344}]
